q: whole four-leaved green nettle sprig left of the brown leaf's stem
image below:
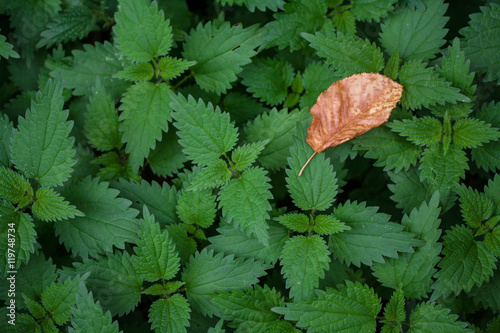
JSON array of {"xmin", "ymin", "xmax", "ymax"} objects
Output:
[{"xmin": 170, "ymin": 94, "xmax": 272, "ymax": 245}]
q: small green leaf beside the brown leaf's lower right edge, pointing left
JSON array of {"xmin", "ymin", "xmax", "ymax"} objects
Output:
[{"xmin": 388, "ymin": 117, "xmax": 443, "ymax": 146}]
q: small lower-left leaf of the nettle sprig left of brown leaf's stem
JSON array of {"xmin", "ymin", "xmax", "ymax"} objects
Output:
[{"xmin": 187, "ymin": 159, "xmax": 232, "ymax": 191}]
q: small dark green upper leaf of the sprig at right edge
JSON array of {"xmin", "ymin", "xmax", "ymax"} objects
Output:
[{"xmin": 457, "ymin": 184, "xmax": 495, "ymax": 228}]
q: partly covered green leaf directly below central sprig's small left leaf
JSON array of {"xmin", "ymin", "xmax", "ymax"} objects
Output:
[{"xmin": 176, "ymin": 190, "xmax": 217, "ymax": 228}]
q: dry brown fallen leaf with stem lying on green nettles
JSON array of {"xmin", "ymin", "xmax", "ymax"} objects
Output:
[{"xmin": 299, "ymin": 73, "xmax": 403, "ymax": 176}]
